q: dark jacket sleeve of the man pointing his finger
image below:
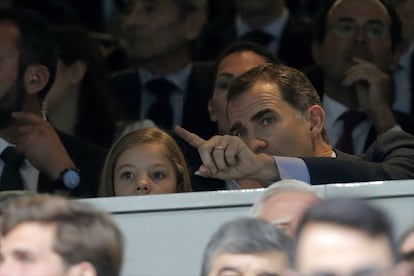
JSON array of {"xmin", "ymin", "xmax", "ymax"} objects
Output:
[{"xmin": 303, "ymin": 131, "xmax": 414, "ymax": 185}]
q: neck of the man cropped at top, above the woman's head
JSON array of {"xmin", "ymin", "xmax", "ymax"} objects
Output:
[{"xmin": 239, "ymin": 4, "xmax": 287, "ymax": 29}]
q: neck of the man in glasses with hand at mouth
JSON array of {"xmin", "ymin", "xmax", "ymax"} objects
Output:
[{"xmin": 324, "ymin": 78, "xmax": 359, "ymax": 109}]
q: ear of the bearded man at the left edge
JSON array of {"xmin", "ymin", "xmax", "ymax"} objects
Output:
[{"xmin": 23, "ymin": 65, "xmax": 50, "ymax": 95}]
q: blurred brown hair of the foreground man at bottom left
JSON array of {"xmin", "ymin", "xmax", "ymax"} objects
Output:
[{"xmin": 1, "ymin": 194, "xmax": 123, "ymax": 276}]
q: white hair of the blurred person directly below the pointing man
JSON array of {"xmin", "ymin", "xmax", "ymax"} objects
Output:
[{"xmin": 250, "ymin": 179, "xmax": 320, "ymax": 217}]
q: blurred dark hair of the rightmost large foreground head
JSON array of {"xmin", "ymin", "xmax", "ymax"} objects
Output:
[{"xmin": 296, "ymin": 198, "xmax": 397, "ymax": 258}]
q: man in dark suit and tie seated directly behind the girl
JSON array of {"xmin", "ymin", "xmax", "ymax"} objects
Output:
[{"xmin": 110, "ymin": 0, "xmax": 216, "ymax": 138}]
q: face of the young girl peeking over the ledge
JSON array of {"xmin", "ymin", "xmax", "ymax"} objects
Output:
[{"xmin": 113, "ymin": 143, "xmax": 177, "ymax": 196}]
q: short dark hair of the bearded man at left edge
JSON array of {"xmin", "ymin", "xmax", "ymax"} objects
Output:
[{"xmin": 0, "ymin": 9, "xmax": 57, "ymax": 100}]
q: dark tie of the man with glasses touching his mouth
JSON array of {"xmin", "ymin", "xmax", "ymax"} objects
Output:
[{"xmin": 335, "ymin": 110, "xmax": 367, "ymax": 154}]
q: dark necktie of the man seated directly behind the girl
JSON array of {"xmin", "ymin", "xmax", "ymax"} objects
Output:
[{"xmin": 147, "ymin": 78, "xmax": 177, "ymax": 129}]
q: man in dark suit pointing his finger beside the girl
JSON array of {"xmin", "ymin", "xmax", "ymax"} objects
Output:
[{"xmin": 176, "ymin": 64, "xmax": 414, "ymax": 186}]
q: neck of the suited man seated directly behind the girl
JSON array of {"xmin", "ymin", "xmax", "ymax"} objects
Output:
[{"xmin": 139, "ymin": 47, "xmax": 191, "ymax": 75}]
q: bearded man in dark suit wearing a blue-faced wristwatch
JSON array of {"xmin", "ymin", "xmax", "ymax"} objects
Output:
[{"xmin": 0, "ymin": 10, "xmax": 105, "ymax": 197}]
